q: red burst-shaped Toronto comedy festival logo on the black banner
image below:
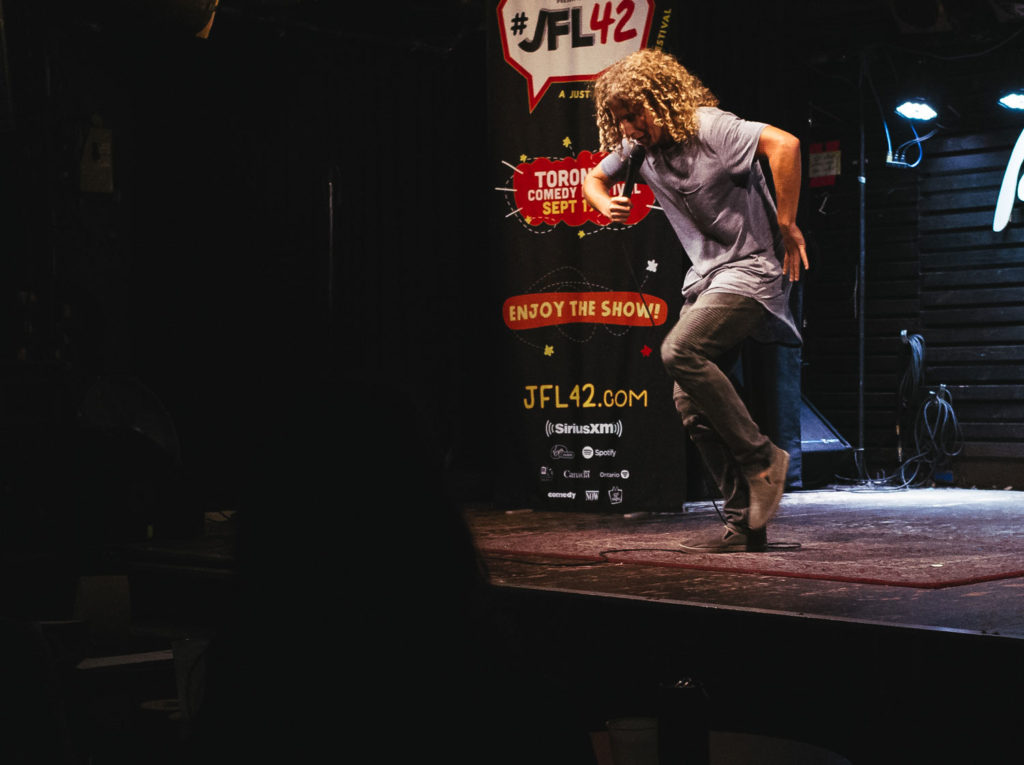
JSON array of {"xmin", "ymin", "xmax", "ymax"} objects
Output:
[{"xmin": 512, "ymin": 152, "xmax": 654, "ymax": 226}]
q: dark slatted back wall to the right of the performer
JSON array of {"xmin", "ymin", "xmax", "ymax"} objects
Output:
[{"xmin": 802, "ymin": 2, "xmax": 1024, "ymax": 487}]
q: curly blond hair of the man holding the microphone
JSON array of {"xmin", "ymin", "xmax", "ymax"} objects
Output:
[{"xmin": 594, "ymin": 48, "xmax": 718, "ymax": 152}]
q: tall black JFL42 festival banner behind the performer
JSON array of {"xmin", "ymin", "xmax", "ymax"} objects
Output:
[{"xmin": 488, "ymin": 0, "xmax": 689, "ymax": 512}]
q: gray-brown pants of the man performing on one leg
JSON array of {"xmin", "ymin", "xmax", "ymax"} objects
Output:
[{"xmin": 662, "ymin": 293, "xmax": 771, "ymax": 530}]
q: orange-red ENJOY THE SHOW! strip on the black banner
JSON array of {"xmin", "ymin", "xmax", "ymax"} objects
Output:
[{"xmin": 502, "ymin": 292, "xmax": 668, "ymax": 330}]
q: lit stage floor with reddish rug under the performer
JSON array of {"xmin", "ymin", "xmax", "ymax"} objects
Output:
[{"xmin": 466, "ymin": 487, "xmax": 1024, "ymax": 638}]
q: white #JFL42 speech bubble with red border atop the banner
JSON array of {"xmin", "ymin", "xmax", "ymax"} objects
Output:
[{"xmin": 498, "ymin": 0, "xmax": 654, "ymax": 112}]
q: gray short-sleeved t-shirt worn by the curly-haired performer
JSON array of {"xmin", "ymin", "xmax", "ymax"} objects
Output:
[{"xmin": 601, "ymin": 107, "xmax": 801, "ymax": 344}]
